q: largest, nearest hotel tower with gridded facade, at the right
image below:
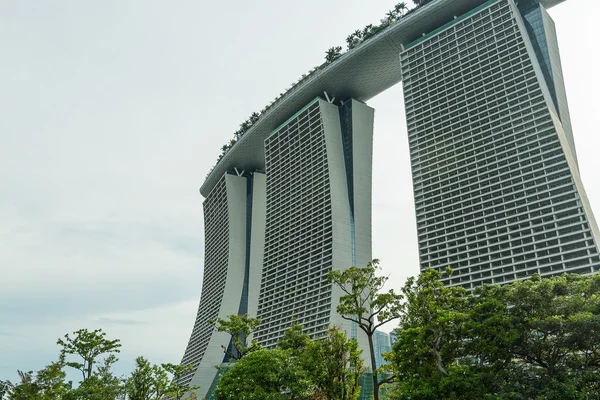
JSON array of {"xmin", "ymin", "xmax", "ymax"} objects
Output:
[{"xmin": 401, "ymin": 0, "xmax": 600, "ymax": 289}]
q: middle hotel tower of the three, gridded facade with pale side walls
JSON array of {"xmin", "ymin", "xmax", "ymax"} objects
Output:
[{"xmin": 256, "ymin": 99, "xmax": 373, "ymax": 347}]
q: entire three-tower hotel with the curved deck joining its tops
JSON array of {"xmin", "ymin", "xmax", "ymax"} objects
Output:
[{"xmin": 182, "ymin": 0, "xmax": 600, "ymax": 396}]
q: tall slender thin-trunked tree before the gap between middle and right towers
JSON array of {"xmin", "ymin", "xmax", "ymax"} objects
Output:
[{"xmin": 329, "ymin": 260, "xmax": 402, "ymax": 400}]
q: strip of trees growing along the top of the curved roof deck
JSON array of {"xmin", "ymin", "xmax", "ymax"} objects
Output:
[{"xmin": 207, "ymin": 0, "xmax": 433, "ymax": 177}]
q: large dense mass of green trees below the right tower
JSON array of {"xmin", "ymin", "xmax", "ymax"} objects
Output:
[{"xmin": 388, "ymin": 270, "xmax": 600, "ymax": 400}]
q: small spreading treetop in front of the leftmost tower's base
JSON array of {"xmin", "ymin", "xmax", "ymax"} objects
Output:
[{"xmin": 210, "ymin": 314, "xmax": 260, "ymax": 360}]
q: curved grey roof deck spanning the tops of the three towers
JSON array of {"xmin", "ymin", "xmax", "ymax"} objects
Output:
[{"xmin": 200, "ymin": 0, "xmax": 564, "ymax": 197}]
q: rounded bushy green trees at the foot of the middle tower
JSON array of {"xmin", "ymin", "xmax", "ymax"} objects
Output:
[{"xmin": 215, "ymin": 324, "xmax": 364, "ymax": 400}]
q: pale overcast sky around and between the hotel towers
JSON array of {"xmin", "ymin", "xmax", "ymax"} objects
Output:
[{"xmin": 0, "ymin": 0, "xmax": 600, "ymax": 380}]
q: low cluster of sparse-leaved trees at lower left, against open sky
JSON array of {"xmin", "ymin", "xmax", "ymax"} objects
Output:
[{"xmin": 0, "ymin": 329, "xmax": 198, "ymax": 400}]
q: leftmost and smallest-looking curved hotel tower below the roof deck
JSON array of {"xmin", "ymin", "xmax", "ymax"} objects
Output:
[{"xmin": 176, "ymin": 171, "xmax": 266, "ymax": 390}]
